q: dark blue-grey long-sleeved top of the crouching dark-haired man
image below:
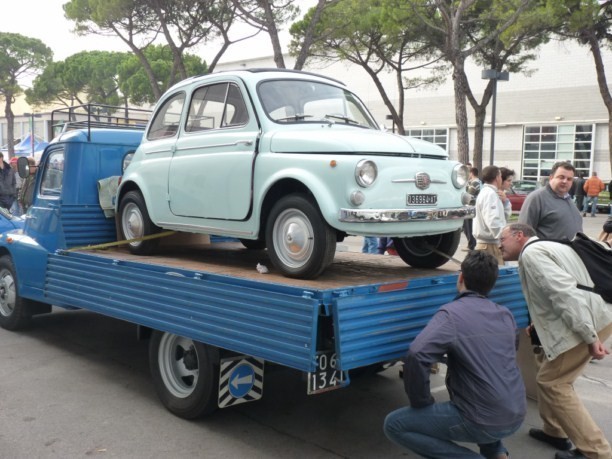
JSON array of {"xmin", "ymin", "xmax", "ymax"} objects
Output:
[{"xmin": 404, "ymin": 291, "xmax": 526, "ymax": 428}]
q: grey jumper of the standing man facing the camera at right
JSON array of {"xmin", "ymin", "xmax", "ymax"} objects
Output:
[{"xmin": 519, "ymin": 184, "xmax": 582, "ymax": 239}]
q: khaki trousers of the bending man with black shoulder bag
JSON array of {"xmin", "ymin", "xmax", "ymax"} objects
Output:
[{"xmin": 536, "ymin": 324, "xmax": 612, "ymax": 459}]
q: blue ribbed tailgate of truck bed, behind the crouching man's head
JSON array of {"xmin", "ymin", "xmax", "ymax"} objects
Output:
[{"xmin": 332, "ymin": 269, "xmax": 527, "ymax": 370}]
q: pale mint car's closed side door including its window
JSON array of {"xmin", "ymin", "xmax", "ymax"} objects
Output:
[{"xmin": 168, "ymin": 81, "xmax": 259, "ymax": 220}]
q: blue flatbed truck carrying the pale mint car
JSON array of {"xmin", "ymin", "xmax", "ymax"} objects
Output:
[{"xmin": 0, "ymin": 108, "xmax": 527, "ymax": 419}]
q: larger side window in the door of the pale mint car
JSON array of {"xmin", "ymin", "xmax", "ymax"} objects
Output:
[{"xmin": 185, "ymin": 83, "xmax": 249, "ymax": 132}]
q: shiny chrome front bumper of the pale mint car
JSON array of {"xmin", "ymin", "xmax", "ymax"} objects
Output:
[{"xmin": 339, "ymin": 206, "xmax": 476, "ymax": 223}]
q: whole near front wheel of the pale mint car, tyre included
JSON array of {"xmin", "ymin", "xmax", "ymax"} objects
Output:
[{"xmin": 266, "ymin": 194, "xmax": 336, "ymax": 279}]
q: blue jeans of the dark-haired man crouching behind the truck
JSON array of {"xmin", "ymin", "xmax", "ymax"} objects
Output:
[{"xmin": 384, "ymin": 402, "xmax": 522, "ymax": 459}]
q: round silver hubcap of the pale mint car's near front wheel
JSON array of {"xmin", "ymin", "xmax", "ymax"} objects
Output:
[{"xmin": 273, "ymin": 209, "xmax": 314, "ymax": 268}]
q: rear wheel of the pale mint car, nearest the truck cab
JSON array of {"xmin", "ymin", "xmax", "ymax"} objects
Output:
[{"xmin": 118, "ymin": 191, "xmax": 161, "ymax": 255}]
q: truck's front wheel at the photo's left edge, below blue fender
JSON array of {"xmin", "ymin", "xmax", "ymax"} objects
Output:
[{"xmin": 0, "ymin": 255, "xmax": 38, "ymax": 330}]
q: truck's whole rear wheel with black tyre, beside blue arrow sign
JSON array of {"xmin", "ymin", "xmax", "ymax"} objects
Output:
[{"xmin": 149, "ymin": 330, "xmax": 219, "ymax": 419}]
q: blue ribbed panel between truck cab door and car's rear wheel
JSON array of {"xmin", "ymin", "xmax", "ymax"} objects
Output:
[{"xmin": 60, "ymin": 204, "xmax": 117, "ymax": 248}]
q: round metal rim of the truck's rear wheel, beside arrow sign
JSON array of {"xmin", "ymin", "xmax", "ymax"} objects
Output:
[{"xmin": 157, "ymin": 333, "xmax": 200, "ymax": 398}]
